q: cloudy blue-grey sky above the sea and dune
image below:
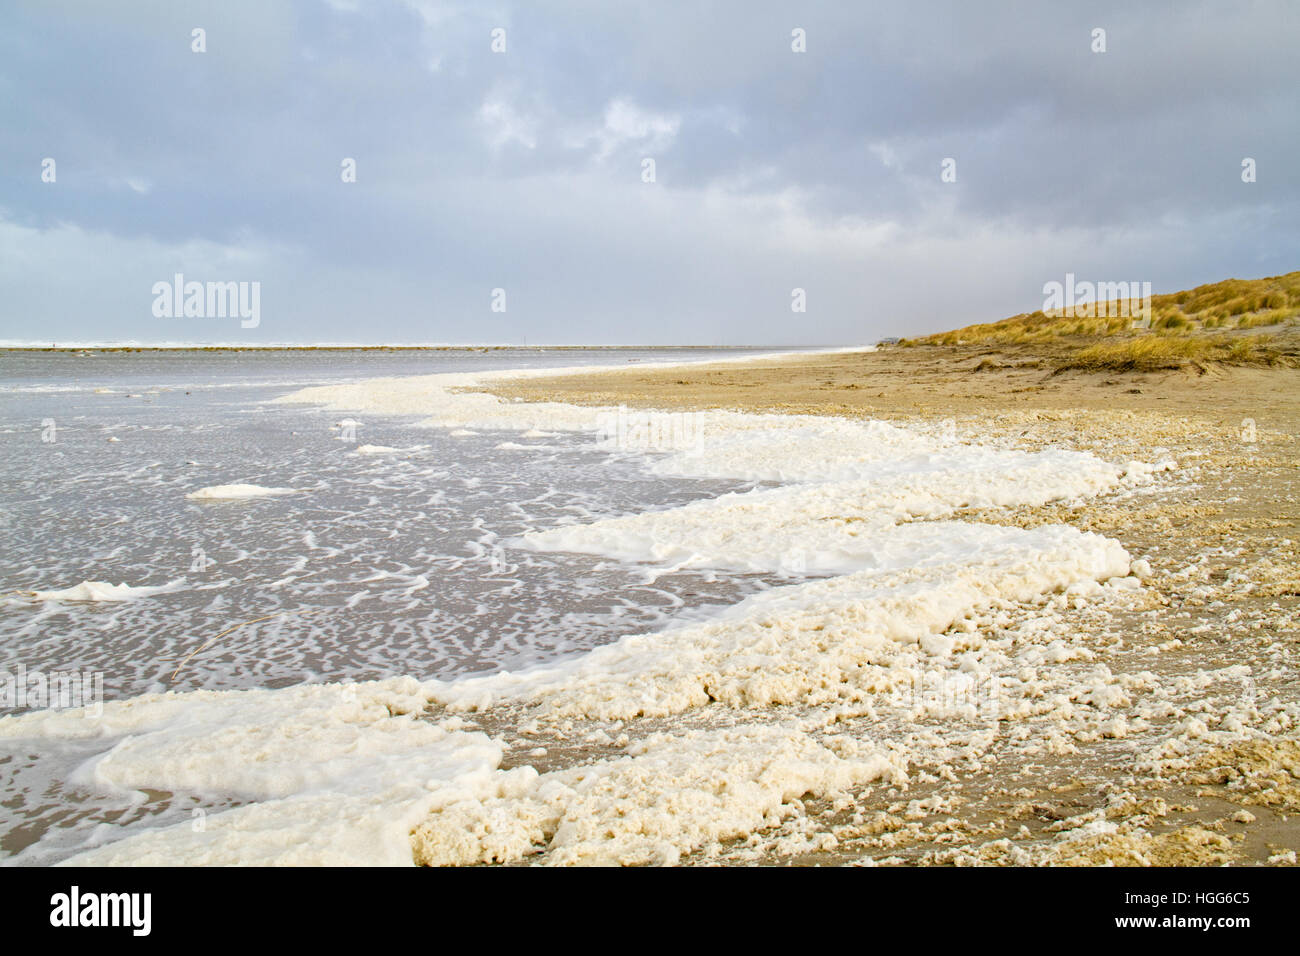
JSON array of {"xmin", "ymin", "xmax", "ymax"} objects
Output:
[{"xmin": 0, "ymin": 0, "xmax": 1300, "ymax": 346}]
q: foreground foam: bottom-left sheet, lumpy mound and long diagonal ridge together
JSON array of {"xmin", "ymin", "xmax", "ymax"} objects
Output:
[{"xmin": 0, "ymin": 523, "xmax": 1127, "ymax": 865}]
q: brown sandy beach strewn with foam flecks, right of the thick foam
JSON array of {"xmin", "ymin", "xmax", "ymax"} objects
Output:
[{"xmin": 475, "ymin": 346, "xmax": 1300, "ymax": 865}]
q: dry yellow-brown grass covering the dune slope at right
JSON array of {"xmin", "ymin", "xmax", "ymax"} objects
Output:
[{"xmin": 902, "ymin": 272, "xmax": 1300, "ymax": 345}]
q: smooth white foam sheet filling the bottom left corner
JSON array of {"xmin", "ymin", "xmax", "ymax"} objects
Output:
[{"xmin": 0, "ymin": 679, "xmax": 502, "ymax": 866}]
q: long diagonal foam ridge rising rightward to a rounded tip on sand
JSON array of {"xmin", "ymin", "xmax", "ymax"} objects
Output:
[{"xmin": 429, "ymin": 523, "xmax": 1128, "ymax": 719}]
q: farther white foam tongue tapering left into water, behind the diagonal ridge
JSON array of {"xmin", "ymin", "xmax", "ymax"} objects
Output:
[{"xmin": 521, "ymin": 446, "xmax": 1126, "ymax": 574}]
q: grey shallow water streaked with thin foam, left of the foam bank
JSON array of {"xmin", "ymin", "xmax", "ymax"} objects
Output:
[{"xmin": 0, "ymin": 350, "xmax": 795, "ymax": 700}]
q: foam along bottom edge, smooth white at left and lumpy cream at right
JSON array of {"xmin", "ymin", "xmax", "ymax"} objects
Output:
[{"xmin": 0, "ymin": 679, "xmax": 904, "ymax": 866}]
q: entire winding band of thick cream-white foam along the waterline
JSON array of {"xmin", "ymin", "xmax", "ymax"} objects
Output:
[{"xmin": 0, "ymin": 351, "xmax": 1175, "ymax": 865}]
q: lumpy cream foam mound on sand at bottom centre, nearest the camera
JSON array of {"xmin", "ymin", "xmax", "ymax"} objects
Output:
[{"xmin": 415, "ymin": 724, "xmax": 906, "ymax": 865}]
